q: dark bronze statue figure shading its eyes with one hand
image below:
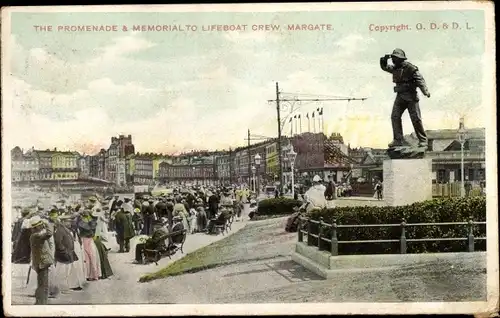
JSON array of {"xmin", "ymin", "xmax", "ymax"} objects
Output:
[{"xmin": 380, "ymin": 49, "xmax": 431, "ymax": 148}]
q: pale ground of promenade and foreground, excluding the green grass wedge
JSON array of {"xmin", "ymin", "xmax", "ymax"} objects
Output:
[{"xmin": 12, "ymin": 199, "xmax": 486, "ymax": 304}]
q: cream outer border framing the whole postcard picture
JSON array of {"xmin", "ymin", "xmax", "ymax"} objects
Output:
[{"xmin": 2, "ymin": 1, "xmax": 499, "ymax": 316}]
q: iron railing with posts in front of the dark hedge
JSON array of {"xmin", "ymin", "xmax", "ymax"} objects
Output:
[{"xmin": 297, "ymin": 217, "xmax": 486, "ymax": 256}]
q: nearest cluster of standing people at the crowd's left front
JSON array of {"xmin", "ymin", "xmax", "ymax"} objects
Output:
[{"xmin": 12, "ymin": 197, "xmax": 113, "ymax": 305}]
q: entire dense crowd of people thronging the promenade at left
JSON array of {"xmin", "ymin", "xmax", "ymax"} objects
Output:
[{"xmin": 12, "ymin": 187, "xmax": 251, "ymax": 305}]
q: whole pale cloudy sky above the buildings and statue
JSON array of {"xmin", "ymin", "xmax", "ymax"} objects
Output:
[{"xmin": 4, "ymin": 10, "xmax": 491, "ymax": 154}]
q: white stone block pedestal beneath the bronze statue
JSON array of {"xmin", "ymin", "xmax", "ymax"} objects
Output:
[{"xmin": 383, "ymin": 159, "xmax": 432, "ymax": 206}]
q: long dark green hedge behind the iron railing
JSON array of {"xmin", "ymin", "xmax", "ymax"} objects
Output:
[{"xmin": 302, "ymin": 196, "xmax": 486, "ymax": 255}]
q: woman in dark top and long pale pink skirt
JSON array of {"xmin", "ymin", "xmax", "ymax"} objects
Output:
[{"xmin": 77, "ymin": 209, "xmax": 101, "ymax": 281}]
